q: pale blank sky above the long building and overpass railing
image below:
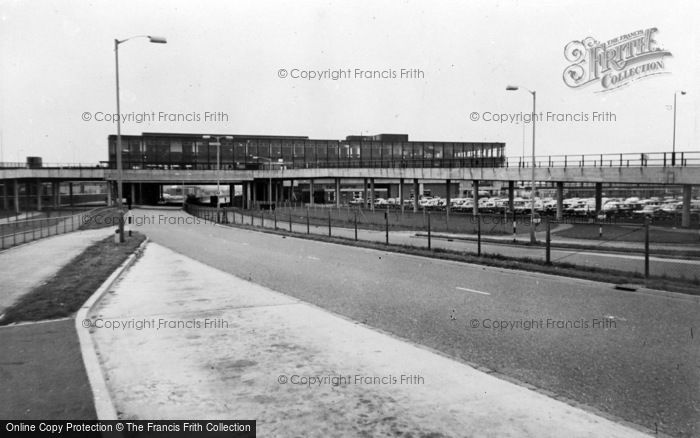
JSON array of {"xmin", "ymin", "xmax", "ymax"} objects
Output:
[{"xmin": 0, "ymin": 0, "xmax": 700, "ymax": 163}]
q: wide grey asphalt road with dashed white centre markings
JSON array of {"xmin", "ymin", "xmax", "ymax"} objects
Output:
[{"xmin": 137, "ymin": 210, "xmax": 700, "ymax": 436}]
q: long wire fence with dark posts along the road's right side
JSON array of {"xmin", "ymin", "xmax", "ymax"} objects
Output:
[{"xmin": 186, "ymin": 204, "xmax": 700, "ymax": 285}]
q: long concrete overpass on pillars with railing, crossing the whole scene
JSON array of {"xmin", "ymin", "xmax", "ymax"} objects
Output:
[{"xmin": 0, "ymin": 151, "xmax": 700, "ymax": 226}]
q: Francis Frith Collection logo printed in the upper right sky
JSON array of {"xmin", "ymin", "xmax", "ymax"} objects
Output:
[{"xmin": 564, "ymin": 27, "xmax": 672, "ymax": 93}]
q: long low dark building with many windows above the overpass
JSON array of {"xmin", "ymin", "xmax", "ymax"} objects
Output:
[{"xmin": 108, "ymin": 132, "xmax": 505, "ymax": 170}]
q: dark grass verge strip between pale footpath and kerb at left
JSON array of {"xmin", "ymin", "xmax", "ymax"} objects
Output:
[{"xmin": 0, "ymin": 233, "xmax": 146, "ymax": 325}]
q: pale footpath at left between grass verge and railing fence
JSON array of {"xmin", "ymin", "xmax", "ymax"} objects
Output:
[{"xmin": 0, "ymin": 227, "xmax": 114, "ymax": 315}]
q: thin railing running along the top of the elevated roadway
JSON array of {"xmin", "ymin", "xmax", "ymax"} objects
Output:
[{"xmin": 0, "ymin": 151, "xmax": 700, "ymax": 170}]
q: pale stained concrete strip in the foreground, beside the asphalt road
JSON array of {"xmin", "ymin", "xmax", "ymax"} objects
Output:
[{"xmin": 91, "ymin": 244, "xmax": 646, "ymax": 437}]
